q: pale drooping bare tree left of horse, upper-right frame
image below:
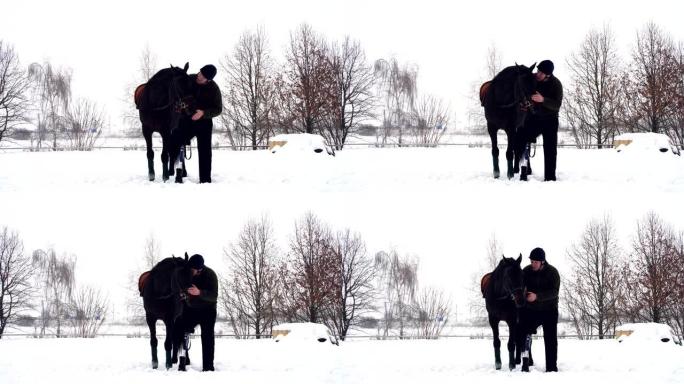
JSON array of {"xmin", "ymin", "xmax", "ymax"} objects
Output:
[{"xmin": 374, "ymin": 57, "xmax": 418, "ymax": 146}]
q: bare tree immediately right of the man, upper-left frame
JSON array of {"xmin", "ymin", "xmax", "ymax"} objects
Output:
[{"xmin": 221, "ymin": 27, "xmax": 276, "ymax": 150}]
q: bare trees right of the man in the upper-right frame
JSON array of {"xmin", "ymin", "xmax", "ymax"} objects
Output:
[{"xmin": 564, "ymin": 22, "xmax": 684, "ymax": 148}]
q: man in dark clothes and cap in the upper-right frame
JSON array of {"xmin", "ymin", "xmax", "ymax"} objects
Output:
[{"xmin": 519, "ymin": 60, "xmax": 563, "ymax": 181}]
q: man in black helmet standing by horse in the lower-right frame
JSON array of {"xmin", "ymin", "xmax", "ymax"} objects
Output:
[{"xmin": 520, "ymin": 248, "xmax": 560, "ymax": 372}]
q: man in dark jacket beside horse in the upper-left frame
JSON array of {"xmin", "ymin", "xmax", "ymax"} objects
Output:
[{"xmin": 176, "ymin": 64, "xmax": 223, "ymax": 183}]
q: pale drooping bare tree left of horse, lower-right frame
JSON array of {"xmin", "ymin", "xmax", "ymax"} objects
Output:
[{"xmin": 375, "ymin": 250, "xmax": 418, "ymax": 338}]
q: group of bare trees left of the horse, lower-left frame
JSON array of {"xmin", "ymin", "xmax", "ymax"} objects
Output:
[{"xmin": 0, "ymin": 227, "xmax": 109, "ymax": 339}]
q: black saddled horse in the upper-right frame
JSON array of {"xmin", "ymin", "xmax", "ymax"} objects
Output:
[{"xmin": 480, "ymin": 63, "xmax": 537, "ymax": 180}]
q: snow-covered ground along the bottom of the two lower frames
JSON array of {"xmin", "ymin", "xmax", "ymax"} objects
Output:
[{"xmin": 0, "ymin": 337, "xmax": 684, "ymax": 384}]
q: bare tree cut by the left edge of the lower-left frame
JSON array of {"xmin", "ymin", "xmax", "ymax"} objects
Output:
[{"xmin": 0, "ymin": 227, "xmax": 34, "ymax": 339}]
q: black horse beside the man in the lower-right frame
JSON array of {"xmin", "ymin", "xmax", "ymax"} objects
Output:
[{"xmin": 480, "ymin": 255, "xmax": 524, "ymax": 370}]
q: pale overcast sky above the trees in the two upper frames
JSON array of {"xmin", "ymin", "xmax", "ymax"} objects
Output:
[{"xmin": 0, "ymin": 0, "xmax": 684, "ymax": 130}]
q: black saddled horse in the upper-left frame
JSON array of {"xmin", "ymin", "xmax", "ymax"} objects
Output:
[{"xmin": 134, "ymin": 63, "xmax": 194, "ymax": 181}]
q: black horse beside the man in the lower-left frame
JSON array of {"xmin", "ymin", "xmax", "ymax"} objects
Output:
[{"xmin": 138, "ymin": 253, "xmax": 192, "ymax": 369}]
